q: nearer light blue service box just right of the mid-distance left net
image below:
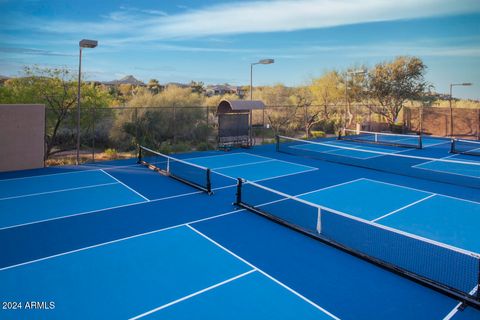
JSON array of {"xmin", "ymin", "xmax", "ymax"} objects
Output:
[{"xmin": 213, "ymin": 159, "xmax": 318, "ymax": 181}]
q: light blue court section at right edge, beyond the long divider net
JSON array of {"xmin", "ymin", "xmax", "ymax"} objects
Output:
[{"xmin": 414, "ymin": 155, "xmax": 480, "ymax": 179}]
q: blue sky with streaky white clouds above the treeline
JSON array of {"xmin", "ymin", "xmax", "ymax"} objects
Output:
[{"xmin": 0, "ymin": 0, "xmax": 480, "ymax": 99}]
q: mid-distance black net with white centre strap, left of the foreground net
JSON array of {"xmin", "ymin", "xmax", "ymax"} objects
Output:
[{"xmin": 138, "ymin": 146, "xmax": 212, "ymax": 194}]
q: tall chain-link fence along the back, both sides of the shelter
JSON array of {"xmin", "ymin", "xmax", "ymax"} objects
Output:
[{"xmin": 45, "ymin": 104, "xmax": 480, "ymax": 165}]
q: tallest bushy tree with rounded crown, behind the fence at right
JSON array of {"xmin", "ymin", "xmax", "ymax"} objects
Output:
[{"xmin": 368, "ymin": 57, "xmax": 430, "ymax": 127}]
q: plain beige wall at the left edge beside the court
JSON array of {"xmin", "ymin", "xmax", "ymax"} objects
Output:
[{"xmin": 0, "ymin": 104, "xmax": 45, "ymax": 172}]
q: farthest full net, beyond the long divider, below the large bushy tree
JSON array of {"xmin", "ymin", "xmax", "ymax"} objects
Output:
[{"xmin": 338, "ymin": 129, "xmax": 422, "ymax": 149}]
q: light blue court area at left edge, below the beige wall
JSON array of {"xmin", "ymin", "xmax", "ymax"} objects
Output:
[{"xmin": 0, "ymin": 171, "xmax": 148, "ymax": 229}]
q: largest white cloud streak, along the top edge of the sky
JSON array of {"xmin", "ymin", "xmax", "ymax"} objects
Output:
[{"xmin": 23, "ymin": 0, "xmax": 480, "ymax": 41}]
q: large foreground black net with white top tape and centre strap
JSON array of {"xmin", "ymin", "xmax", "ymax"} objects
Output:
[{"xmin": 236, "ymin": 178, "xmax": 480, "ymax": 307}]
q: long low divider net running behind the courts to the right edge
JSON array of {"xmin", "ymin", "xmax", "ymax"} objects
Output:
[{"xmin": 276, "ymin": 136, "xmax": 480, "ymax": 188}]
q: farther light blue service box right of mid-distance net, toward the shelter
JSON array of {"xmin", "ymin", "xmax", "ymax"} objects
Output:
[{"xmin": 185, "ymin": 152, "xmax": 272, "ymax": 169}]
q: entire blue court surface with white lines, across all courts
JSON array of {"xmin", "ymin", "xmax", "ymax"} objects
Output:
[{"xmin": 0, "ymin": 137, "xmax": 480, "ymax": 319}]
